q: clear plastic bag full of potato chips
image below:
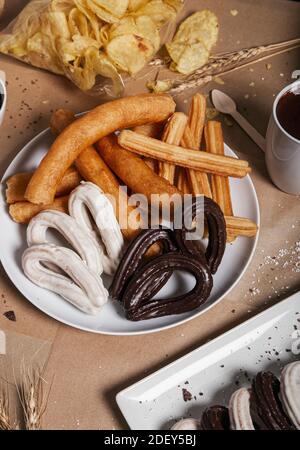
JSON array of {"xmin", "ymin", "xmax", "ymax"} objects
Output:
[{"xmin": 0, "ymin": 0, "xmax": 184, "ymax": 96}]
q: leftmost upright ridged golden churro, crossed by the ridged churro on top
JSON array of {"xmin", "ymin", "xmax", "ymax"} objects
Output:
[{"xmin": 158, "ymin": 112, "xmax": 188, "ymax": 184}]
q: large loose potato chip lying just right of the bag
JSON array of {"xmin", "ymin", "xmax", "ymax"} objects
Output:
[{"xmin": 166, "ymin": 10, "xmax": 219, "ymax": 74}]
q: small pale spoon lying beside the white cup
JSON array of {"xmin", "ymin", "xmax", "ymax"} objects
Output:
[{"xmin": 211, "ymin": 89, "xmax": 266, "ymax": 151}]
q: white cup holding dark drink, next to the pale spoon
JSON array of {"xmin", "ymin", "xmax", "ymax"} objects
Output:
[{"xmin": 266, "ymin": 80, "xmax": 300, "ymax": 195}]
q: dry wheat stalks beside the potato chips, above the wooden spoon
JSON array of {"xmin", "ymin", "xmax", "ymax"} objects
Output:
[{"xmin": 150, "ymin": 38, "xmax": 300, "ymax": 94}]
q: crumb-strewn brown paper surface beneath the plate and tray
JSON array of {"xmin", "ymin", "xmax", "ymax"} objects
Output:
[{"xmin": 0, "ymin": 0, "xmax": 300, "ymax": 429}]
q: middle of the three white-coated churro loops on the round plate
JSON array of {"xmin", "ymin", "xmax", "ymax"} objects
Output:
[{"xmin": 27, "ymin": 210, "xmax": 103, "ymax": 275}]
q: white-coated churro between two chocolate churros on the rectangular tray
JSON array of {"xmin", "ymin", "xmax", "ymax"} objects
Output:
[{"xmin": 229, "ymin": 388, "xmax": 255, "ymax": 430}]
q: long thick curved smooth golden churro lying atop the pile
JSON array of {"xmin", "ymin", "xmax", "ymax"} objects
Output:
[{"xmin": 25, "ymin": 94, "xmax": 175, "ymax": 205}]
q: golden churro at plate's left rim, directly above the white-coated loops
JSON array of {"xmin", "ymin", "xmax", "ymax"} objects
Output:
[{"xmin": 9, "ymin": 195, "xmax": 69, "ymax": 224}]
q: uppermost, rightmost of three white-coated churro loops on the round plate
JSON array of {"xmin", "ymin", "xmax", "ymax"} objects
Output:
[{"xmin": 69, "ymin": 182, "xmax": 124, "ymax": 275}]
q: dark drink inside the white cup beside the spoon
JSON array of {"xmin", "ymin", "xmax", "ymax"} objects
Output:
[{"xmin": 276, "ymin": 91, "xmax": 300, "ymax": 140}]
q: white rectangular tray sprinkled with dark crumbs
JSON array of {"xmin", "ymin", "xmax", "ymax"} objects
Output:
[{"xmin": 116, "ymin": 292, "xmax": 300, "ymax": 430}]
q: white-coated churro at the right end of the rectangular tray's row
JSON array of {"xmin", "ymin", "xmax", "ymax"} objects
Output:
[{"xmin": 280, "ymin": 361, "xmax": 300, "ymax": 430}]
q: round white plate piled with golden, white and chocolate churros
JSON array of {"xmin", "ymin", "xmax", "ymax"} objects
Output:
[{"xmin": 0, "ymin": 94, "xmax": 260, "ymax": 335}]
